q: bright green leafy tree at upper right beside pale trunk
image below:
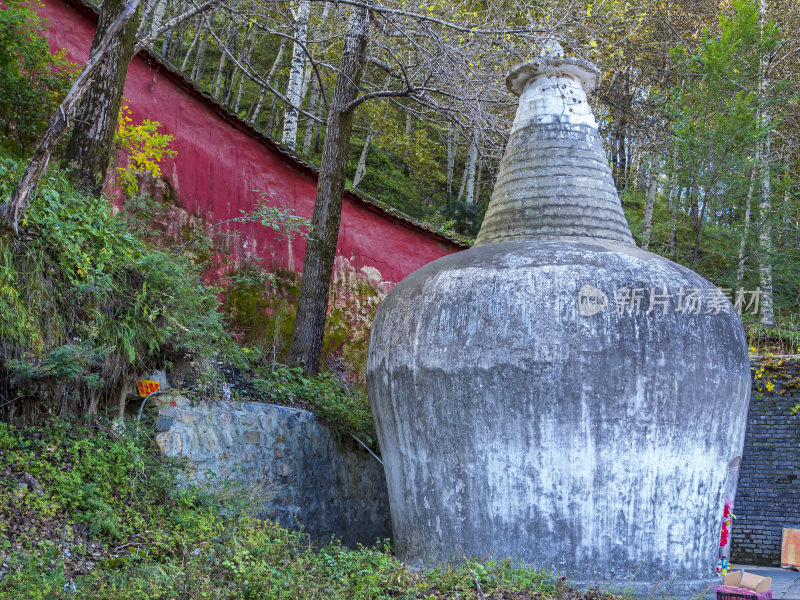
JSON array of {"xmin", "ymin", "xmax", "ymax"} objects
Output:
[{"xmin": 667, "ymin": 0, "xmax": 779, "ymax": 241}]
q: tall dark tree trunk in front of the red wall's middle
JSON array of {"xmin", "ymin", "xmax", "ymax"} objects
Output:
[{"xmin": 288, "ymin": 6, "xmax": 370, "ymax": 373}]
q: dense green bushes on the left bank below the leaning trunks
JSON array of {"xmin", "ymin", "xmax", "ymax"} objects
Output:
[{"xmin": 0, "ymin": 148, "xmax": 232, "ymax": 410}]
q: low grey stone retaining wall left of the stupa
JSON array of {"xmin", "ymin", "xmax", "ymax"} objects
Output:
[{"xmin": 156, "ymin": 397, "xmax": 391, "ymax": 546}]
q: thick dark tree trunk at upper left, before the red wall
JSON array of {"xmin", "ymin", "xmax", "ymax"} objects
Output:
[{"xmin": 64, "ymin": 0, "xmax": 144, "ymax": 193}]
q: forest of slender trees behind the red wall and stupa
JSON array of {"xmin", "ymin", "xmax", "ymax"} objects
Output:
[{"xmin": 120, "ymin": 0, "xmax": 800, "ymax": 332}]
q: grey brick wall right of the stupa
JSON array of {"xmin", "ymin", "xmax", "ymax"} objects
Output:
[{"xmin": 731, "ymin": 358, "xmax": 800, "ymax": 565}]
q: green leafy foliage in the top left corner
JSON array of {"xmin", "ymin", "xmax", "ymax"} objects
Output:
[{"xmin": 0, "ymin": 0, "xmax": 74, "ymax": 154}]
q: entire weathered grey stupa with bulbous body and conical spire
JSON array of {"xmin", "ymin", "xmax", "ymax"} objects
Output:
[{"xmin": 367, "ymin": 44, "xmax": 750, "ymax": 593}]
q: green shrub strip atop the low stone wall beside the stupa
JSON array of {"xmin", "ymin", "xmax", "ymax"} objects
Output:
[{"xmin": 253, "ymin": 364, "xmax": 377, "ymax": 448}]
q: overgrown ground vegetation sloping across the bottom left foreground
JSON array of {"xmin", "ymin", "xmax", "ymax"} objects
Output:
[{"xmin": 0, "ymin": 420, "xmax": 624, "ymax": 600}]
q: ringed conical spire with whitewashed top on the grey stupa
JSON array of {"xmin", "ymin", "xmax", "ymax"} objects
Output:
[{"xmin": 475, "ymin": 44, "xmax": 634, "ymax": 246}]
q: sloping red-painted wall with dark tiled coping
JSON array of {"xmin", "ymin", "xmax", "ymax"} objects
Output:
[{"xmin": 39, "ymin": 0, "xmax": 462, "ymax": 285}]
